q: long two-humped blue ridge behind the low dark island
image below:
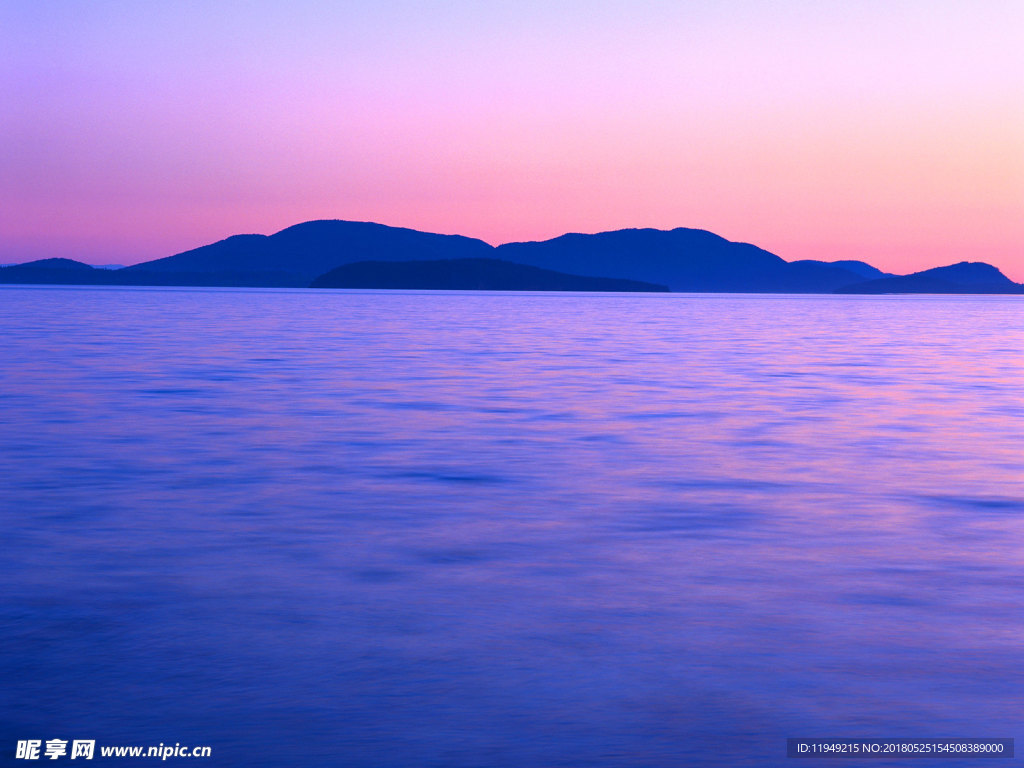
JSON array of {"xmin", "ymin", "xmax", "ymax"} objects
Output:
[{"xmin": 0, "ymin": 225, "xmax": 872, "ymax": 293}]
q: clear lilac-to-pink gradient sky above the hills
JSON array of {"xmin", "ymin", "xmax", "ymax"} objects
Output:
[{"xmin": 0, "ymin": 0, "xmax": 1024, "ymax": 281}]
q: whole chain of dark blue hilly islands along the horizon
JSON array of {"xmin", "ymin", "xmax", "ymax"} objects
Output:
[{"xmin": 0, "ymin": 220, "xmax": 1024, "ymax": 294}]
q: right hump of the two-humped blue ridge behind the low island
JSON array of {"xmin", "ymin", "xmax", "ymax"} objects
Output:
[{"xmin": 497, "ymin": 227, "xmax": 863, "ymax": 293}]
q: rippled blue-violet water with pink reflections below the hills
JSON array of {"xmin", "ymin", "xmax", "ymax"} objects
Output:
[{"xmin": 0, "ymin": 287, "xmax": 1024, "ymax": 768}]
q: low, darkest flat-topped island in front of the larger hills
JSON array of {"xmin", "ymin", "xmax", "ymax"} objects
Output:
[{"xmin": 311, "ymin": 259, "xmax": 669, "ymax": 292}]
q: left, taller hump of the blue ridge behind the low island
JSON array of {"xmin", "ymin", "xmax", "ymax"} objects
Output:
[{"xmin": 125, "ymin": 221, "xmax": 494, "ymax": 286}]
